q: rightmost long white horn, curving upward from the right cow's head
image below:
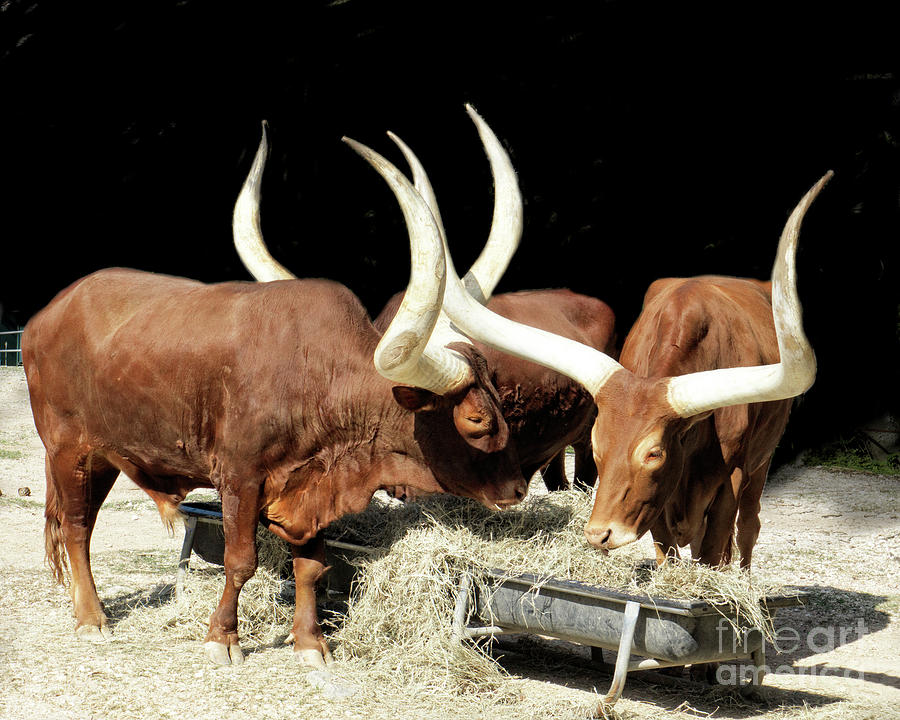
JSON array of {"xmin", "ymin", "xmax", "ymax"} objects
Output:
[{"xmin": 667, "ymin": 170, "xmax": 834, "ymax": 417}]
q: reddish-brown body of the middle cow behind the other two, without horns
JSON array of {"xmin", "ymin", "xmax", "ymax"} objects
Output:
[{"xmin": 375, "ymin": 289, "xmax": 616, "ymax": 497}]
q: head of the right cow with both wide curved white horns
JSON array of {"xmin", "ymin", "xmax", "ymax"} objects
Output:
[{"xmin": 432, "ymin": 172, "xmax": 831, "ymax": 549}]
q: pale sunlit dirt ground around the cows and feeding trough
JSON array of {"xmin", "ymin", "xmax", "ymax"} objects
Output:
[{"xmin": 0, "ymin": 368, "xmax": 900, "ymax": 720}]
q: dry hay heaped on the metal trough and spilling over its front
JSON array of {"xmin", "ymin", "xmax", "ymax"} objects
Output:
[{"xmin": 327, "ymin": 491, "xmax": 776, "ymax": 694}]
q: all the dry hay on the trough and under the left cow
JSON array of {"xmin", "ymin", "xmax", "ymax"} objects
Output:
[{"xmin": 117, "ymin": 491, "xmax": 776, "ymax": 704}]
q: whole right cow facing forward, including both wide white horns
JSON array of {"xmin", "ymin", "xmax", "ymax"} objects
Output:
[{"xmin": 420, "ymin": 172, "xmax": 831, "ymax": 567}]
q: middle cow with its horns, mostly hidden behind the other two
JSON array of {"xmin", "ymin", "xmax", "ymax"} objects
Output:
[{"xmin": 234, "ymin": 105, "xmax": 615, "ymax": 497}]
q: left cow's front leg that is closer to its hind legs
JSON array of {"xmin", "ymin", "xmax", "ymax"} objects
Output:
[{"xmin": 204, "ymin": 491, "xmax": 259, "ymax": 665}]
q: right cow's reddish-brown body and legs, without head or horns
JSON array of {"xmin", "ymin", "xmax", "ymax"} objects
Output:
[{"xmin": 616, "ymin": 276, "xmax": 793, "ymax": 567}]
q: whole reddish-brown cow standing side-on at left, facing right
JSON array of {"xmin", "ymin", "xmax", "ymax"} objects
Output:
[{"xmin": 22, "ymin": 141, "xmax": 526, "ymax": 664}]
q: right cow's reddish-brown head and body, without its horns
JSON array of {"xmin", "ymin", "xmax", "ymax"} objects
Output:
[{"xmin": 585, "ymin": 276, "xmax": 792, "ymax": 567}]
